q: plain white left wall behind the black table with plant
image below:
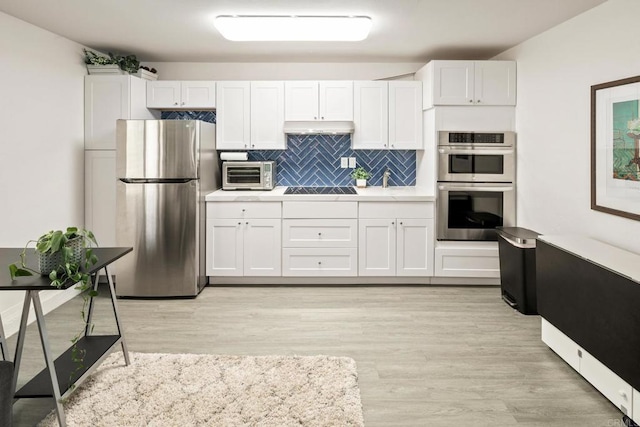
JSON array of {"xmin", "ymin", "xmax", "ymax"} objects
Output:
[{"xmin": 0, "ymin": 12, "xmax": 86, "ymax": 334}]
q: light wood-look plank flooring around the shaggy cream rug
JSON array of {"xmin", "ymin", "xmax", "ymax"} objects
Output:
[{"xmin": 9, "ymin": 286, "xmax": 622, "ymax": 427}]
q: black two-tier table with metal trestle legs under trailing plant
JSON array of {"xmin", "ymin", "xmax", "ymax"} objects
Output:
[{"xmin": 0, "ymin": 248, "xmax": 132, "ymax": 427}]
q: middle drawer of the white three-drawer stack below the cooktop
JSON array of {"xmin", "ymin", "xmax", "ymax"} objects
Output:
[{"xmin": 282, "ymin": 219, "xmax": 358, "ymax": 248}]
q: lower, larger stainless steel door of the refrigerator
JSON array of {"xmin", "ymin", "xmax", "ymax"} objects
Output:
[{"xmin": 116, "ymin": 181, "xmax": 206, "ymax": 297}]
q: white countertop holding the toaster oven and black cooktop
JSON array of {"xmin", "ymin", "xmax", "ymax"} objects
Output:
[{"xmin": 205, "ymin": 186, "xmax": 436, "ymax": 202}]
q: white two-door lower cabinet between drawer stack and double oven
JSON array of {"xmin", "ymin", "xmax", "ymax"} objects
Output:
[{"xmin": 358, "ymin": 202, "xmax": 434, "ymax": 277}]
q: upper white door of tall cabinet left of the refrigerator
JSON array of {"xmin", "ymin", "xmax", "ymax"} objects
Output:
[{"xmin": 84, "ymin": 76, "xmax": 131, "ymax": 150}]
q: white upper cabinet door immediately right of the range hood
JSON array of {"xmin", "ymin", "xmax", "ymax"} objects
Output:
[{"xmin": 352, "ymin": 81, "xmax": 389, "ymax": 149}]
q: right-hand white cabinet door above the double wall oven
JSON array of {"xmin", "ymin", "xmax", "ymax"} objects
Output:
[{"xmin": 474, "ymin": 61, "xmax": 516, "ymax": 105}]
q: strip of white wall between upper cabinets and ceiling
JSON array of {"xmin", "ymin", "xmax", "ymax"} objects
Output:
[{"xmin": 142, "ymin": 62, "xmax": 424, "ymax": 80}]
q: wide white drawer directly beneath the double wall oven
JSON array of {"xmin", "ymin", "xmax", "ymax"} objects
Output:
[{"xmin": 435, "ymin": 242, "xmax": 500, "ymax": 278}]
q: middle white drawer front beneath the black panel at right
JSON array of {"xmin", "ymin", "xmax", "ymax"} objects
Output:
[{"xmin": 580, "ymin": 350, "xmax": 633, "ymax": 415}]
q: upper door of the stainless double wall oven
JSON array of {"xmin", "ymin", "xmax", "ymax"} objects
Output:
[{"xmin": 438, "ymin": 145, "xmax": 516, "ymax": 182}]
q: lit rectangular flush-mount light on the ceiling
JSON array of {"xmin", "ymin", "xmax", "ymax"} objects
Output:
[{"xmin": 215, "ymin": 15, "xmax": 371, "ymax": 41}]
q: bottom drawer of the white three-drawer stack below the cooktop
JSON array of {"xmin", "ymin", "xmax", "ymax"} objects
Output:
[{"xmin": 282, "ymin": 248, "xmax": 358, "ymax": 276}]
